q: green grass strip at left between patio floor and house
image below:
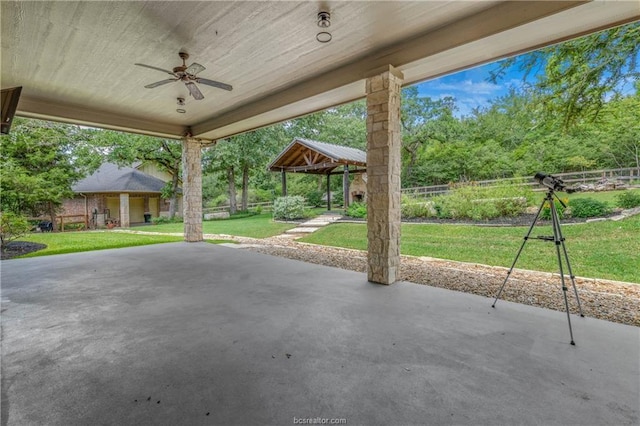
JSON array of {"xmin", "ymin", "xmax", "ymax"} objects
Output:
[{"xmin": 20, "ymin": 232, "xmax": 184, "ymax": 258}]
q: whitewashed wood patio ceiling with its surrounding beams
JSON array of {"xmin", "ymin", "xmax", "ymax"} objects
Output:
[{"xmin": 1, "ymin": 1, "xmax": 640, "ymax": 141}]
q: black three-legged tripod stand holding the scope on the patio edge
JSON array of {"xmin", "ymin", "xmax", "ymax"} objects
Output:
[{"xmin": 491, "ymin": 188, "xmax": 584, "ymax": 345}]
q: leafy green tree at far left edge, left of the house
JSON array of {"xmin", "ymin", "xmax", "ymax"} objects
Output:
[{"xmin": 0, "ymin": 118, "xmax": 100, "ymax": 223}]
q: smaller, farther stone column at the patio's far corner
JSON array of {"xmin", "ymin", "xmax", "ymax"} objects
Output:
[{"xmin": 182, "ymin": 137, "xmax": 203, "ymax": 242}]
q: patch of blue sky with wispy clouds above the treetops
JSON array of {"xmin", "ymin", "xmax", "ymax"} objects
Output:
[{"xmin": 417, "ymin": 63, "xmax": 531, "ymax": 116}]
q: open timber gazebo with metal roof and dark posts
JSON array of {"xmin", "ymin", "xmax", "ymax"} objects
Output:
[{"xmin": 268, "ymin": 138, "xmax": 367, "ymax": 210}]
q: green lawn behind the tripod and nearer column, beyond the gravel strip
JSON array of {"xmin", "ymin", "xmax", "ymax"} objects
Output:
[{"xmin": 300, "ymin": 216, "xmax": 640, "ymax": 283}]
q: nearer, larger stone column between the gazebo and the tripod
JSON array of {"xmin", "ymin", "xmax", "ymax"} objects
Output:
[{"xmin": 366, "ymin": 65, "xmax": 404, "ymax": 284}]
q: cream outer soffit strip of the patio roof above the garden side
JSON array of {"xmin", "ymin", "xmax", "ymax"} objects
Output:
[{"xmin": 194, "ymin": 0, "xmax": 640, "ymax": 140}]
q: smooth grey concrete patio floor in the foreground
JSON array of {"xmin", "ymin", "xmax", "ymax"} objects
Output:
[{"xmin": 1, "ymin": 243, "xmax": 640, "ymax": 425}]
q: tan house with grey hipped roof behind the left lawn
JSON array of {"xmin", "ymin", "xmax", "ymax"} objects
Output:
[{"xmin": 61, "ymin": 163, "xmax": 182, "ymax": 227}]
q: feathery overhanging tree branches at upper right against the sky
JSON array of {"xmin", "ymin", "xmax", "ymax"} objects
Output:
[{"xmin": 492, "ymin": 22, "xmax": 640, "ymax": 129}]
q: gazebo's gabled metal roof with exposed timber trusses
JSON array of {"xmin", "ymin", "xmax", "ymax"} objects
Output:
[{"xmin": 268, "ymin": 138, "xmax": 367, "ymax": 174}]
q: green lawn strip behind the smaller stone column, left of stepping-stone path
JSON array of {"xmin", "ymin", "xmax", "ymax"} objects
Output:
[{"xmin": 134, "ymin": 213, "xmax": 296, "ymax": 238}]
